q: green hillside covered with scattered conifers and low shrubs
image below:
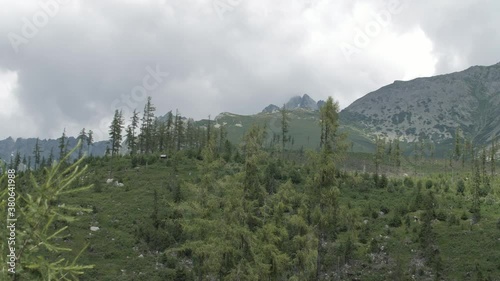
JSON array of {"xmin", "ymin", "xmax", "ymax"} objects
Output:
[{"xmin": 0, "ymin": 97, "xmax": 500, "ymax": 281}]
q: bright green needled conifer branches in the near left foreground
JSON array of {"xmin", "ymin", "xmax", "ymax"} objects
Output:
[{"xmin": 0, "ymin": 143, "xmax": 93, "ymax": 281}]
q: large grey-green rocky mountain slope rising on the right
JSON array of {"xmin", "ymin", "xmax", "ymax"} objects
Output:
[{"xmin": 341, "ymin": 63, "xmax": 500, "ymax": 144}]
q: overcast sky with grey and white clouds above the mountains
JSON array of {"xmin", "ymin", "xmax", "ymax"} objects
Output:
[{"xmin": 0, "ymin": 0, "xmax": 500, "ymax": 139}]
